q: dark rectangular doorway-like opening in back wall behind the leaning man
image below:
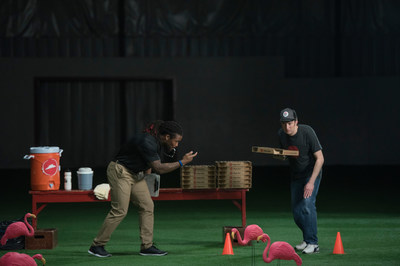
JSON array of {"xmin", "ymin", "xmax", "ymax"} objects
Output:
[{"xmin": 35, "ymin": 79, "xmax": 173, "ymax": 168}]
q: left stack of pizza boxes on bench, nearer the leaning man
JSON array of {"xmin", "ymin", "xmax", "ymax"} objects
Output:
[{"xmin": 181, "ymin": 165, "xmax": 217, "ymax": 189}]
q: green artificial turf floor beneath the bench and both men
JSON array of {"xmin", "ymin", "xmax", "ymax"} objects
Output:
[{"xmin": 0, "ymin": 166, "xmax": 400, "ymax": 266}]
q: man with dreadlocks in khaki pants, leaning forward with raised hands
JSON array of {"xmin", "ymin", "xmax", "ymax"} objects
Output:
[{"xmin": 88, "ymin": 121, "xmax": 197, "ymax": 257}]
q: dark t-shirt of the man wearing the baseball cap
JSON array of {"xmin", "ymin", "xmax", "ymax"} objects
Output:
[{"xmin": 278, "ymin": 125, "xmax": 322, "ymax": 179}]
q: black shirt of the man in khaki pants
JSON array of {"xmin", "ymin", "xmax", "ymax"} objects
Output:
[{"xmin": 115, "ymin": 133, "xmax": 161, "ymax": 173}]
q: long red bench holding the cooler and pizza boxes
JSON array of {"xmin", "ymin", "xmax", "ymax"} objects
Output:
[{"xmin": 29, "ymin": 188, "xmax": 249, "ymax": 230}]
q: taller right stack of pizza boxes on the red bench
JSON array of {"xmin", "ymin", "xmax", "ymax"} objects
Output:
[{"xmin": 216, "ymin": 161, "xmax": 252, "ymax": 188}]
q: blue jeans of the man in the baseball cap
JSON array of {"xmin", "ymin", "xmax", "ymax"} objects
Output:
[{"xmin": 290, "ymin": 170, "xmax": 322, "ymax": 245}]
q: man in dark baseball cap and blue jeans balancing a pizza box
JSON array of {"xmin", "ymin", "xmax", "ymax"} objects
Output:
[{"xmin": 278, "ymin": 108, "xmax": 324, "ymax": 254}]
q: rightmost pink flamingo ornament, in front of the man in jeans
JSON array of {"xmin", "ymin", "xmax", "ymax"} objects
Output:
[{"xmin": 263, "ymin": 235, "xmax": 303, "ymax": 266}]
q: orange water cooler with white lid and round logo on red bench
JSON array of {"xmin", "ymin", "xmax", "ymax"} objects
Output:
[{"xmin": 24, "ymin": 146, "xmax": 63, "ymax": 190}]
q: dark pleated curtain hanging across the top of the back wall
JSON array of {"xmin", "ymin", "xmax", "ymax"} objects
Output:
[{"xmin": 0, "ymin": 0, "xmax": 400, "ymax": 77}]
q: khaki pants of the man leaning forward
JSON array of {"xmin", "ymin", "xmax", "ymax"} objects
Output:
[{"xmin": 92, "ymin": 162, "xmax": 154, "ymax": 249}]
